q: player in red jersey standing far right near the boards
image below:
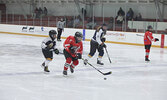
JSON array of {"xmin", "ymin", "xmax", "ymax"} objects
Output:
[{"xmin": 144, "ymin": 25, "xmax": 159, "ymax": 61}]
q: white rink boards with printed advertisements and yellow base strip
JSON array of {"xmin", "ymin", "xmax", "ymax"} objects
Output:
[{"xmin": 0, "ymin": 24, "xmax": 167, "ymax": 48}]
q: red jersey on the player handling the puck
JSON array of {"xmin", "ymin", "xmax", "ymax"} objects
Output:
[{"xmin": 63, "ymin": 36, "xmax": 83, "ymax": 57}]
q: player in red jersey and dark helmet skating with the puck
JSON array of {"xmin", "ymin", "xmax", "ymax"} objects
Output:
[{"xmin": 63, "ymin": 32, "xmax": 83, "ymax": 75}]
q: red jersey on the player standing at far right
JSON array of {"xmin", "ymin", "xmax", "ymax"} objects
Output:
[{"xmin": 144, "ymin": 31, "xmax": 154, "ymax": 45}]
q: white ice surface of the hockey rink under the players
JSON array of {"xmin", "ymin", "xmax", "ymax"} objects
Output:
[{"xmin": 0, "ymin": 34, "xmax": 167, "ymax": 100}]
